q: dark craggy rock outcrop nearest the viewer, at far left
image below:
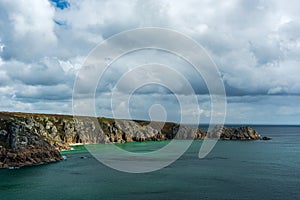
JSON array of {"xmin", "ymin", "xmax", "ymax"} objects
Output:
[{"xmin": 0, "ymin": 115, "xmax": 62, "ymax": 168}]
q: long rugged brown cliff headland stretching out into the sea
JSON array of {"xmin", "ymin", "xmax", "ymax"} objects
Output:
[{"xmin": 0, "ymin": 112, "xmax": 268, "ymax": 168}]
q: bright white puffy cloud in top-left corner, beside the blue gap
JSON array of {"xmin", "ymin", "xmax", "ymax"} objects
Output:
[{"xmin": 0, "ymin": 0, "xmax": 57, "ymax": 60}]
